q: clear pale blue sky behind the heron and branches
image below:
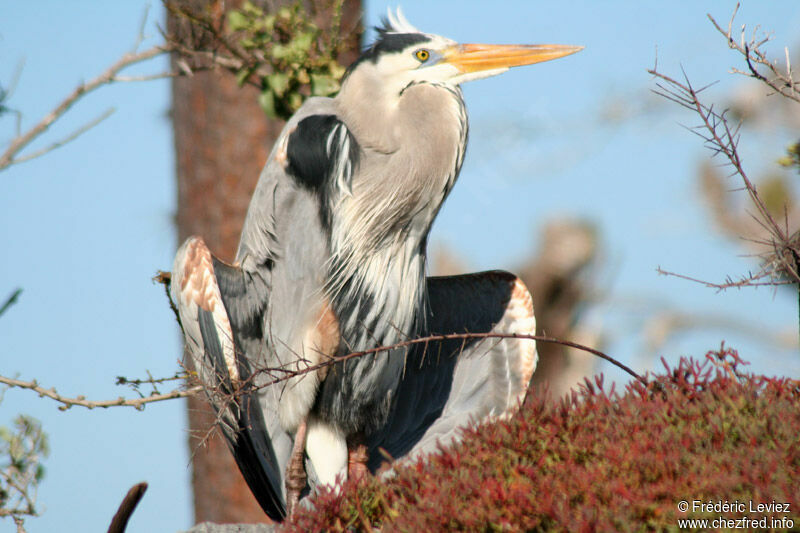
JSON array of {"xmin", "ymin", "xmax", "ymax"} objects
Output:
[{"xmin": 0, "ymin": 0, "xmax": 800, "ymax": 533}]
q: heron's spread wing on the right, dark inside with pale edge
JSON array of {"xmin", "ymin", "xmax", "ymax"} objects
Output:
[{"xmin": 368, "ymin": 271, "xmax": 537, "ymax": 471}]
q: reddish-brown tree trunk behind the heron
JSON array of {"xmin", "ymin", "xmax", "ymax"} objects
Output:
[{"xmin": 168, "ymin": 0, "xmax": 361, "ymax": 523}]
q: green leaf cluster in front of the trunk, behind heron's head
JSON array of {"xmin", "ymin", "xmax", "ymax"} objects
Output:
[{"xmin": 227, "ymin": 0, "xmax": 345, "ymax": 119}]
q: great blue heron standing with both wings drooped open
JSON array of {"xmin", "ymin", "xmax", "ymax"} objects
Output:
[{"xmin": 172, "ymin": 10, "xmax": 581, "ymax": 520}]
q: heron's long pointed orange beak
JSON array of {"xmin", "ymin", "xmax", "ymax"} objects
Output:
[{"xmin": 443, "ymin": 44, "xmax": 583, "ymax": 74}]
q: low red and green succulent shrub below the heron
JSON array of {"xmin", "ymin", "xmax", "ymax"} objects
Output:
[{"xmin": 286, "ymin": 347, "xmax": 800, "ymax": 531}]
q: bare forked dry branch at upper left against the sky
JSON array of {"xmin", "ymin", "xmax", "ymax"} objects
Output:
[{"xmin": 0, "ymin": 45, "xmax": 170, "ymax": 171}]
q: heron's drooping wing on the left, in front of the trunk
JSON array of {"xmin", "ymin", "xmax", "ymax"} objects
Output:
[{"xmin": 171, "ymin": 237, "xmax": 286, "ymax": 520}]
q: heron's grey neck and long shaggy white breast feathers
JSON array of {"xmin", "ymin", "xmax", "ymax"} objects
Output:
[{"xmin": 329, "ymin": 78, "xmax": 468, "ymax": 344}]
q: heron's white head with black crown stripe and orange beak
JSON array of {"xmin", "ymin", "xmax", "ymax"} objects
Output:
[{"xmin": 343, "ymin": 9, "xmax": 583, "ymax": 94}]
